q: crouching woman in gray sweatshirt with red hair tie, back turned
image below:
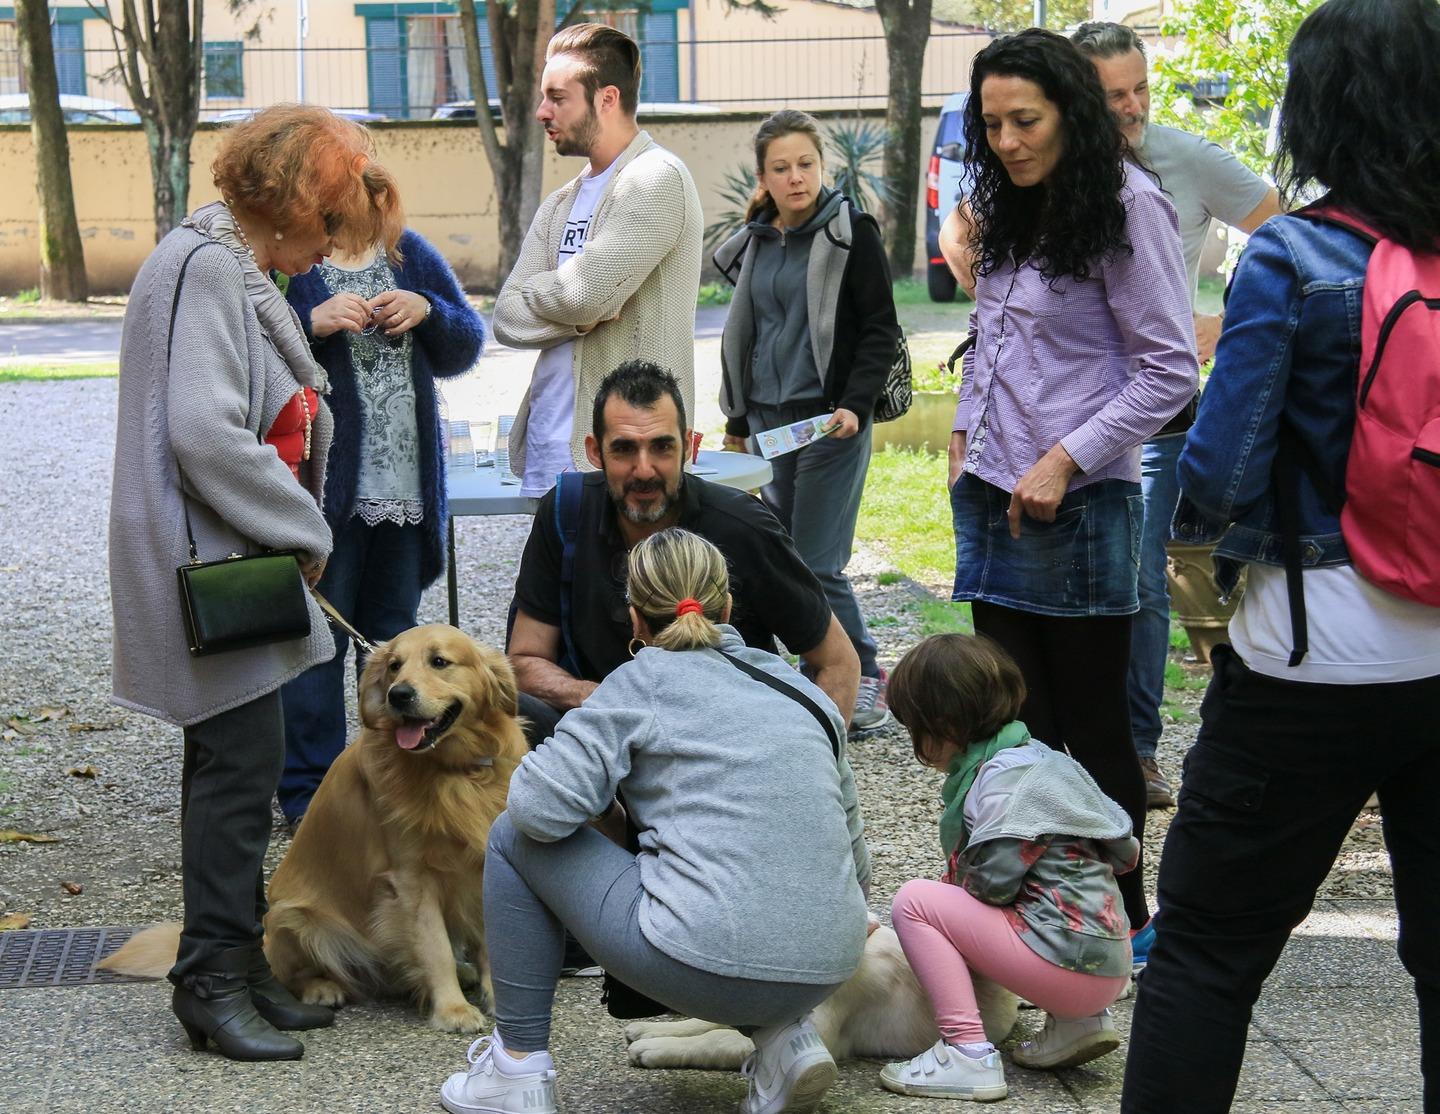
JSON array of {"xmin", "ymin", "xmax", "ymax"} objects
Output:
[{"xmin": 441, "ymin": 530, "xmax": 870, "ymax": 1114}]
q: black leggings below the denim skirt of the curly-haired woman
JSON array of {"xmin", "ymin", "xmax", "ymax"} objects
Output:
[{"xmin": 971, "ymin": 600, "xmax": 1149, "ymax": 928}]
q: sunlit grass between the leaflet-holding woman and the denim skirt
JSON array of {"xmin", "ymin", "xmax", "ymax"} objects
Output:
[{"xmin": 855, "ymin": 446, "xmax": 955, "ymax": 586}]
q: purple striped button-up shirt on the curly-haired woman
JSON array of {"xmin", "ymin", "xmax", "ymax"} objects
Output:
[{"xmin": 952, "ymin": 164, "xmax": 1200, "ymax": 491}]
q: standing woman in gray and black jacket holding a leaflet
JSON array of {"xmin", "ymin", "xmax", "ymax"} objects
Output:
[{"xmin": 716, "ymin": 108, "xmax": 900, "ymax": 731}]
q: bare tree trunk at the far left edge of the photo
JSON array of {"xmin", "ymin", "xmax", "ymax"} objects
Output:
[{"xmin": 16, "ymin": 0, "xmax": 89, "ymax": 302}]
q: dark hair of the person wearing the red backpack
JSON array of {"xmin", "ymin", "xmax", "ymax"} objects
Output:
[{"xmin": 1274, "ymin": 0, "xmax": 1440, "ymax": 250}]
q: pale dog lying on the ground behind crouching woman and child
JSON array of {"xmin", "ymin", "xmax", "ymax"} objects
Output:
[{"xmin": 625, "ymin": 927, "xmax": 1020, "ymax": 1071}]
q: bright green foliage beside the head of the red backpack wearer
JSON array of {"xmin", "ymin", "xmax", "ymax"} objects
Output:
[{"xmin": 1151, "ymin": 0, "xmax": 1320, "ymax": 173}]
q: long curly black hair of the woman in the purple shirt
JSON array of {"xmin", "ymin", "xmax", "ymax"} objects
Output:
[{"xmin": 965, "ymin": 27, "xmax": 1130, "ymax": 284}]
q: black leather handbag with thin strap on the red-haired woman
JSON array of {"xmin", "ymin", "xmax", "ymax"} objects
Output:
[{"xmin": 166, "ymin": 237, "xmax": 310, "ymax": 658}]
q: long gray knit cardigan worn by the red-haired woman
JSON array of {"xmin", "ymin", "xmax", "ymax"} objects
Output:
[{"xmin": 109, "ymin": 227, "xmax": 336, "ymax": 727}]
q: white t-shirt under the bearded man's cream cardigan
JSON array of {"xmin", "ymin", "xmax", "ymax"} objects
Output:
[{"xmin": 520, "ymin": 163, "xmax": 615, "ymax": 498}]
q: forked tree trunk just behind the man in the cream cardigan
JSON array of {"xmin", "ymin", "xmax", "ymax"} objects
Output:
[{"xmin": 459, "ymin": 0, "xmax": 556, "ymax": 286}]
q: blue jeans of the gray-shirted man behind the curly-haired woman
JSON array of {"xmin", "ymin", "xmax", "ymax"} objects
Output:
[{"xmin": 1128, "ymin": 433, "xmax": 1185, "ymax": 758}]
